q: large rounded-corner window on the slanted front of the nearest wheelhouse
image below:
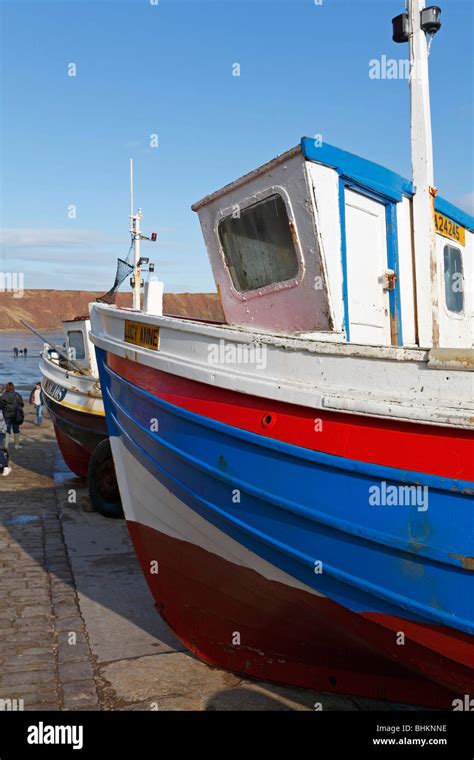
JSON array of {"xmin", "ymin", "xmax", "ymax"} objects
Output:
[{"xmin": 218, "ymin": 194, "xmax": 298, "ymax": 292}]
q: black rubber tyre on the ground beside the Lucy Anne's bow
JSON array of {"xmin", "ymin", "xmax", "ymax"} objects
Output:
[{"xmin": 87, "ymin": 438, "xmax": 124, "ymax": 519}]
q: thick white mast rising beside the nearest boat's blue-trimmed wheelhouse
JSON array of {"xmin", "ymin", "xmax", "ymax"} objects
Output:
[{"xmin": 406, "ymin": 0, "xmax": 439, "ymax": 347}]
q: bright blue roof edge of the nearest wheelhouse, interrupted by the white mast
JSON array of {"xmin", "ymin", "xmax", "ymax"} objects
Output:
[{"xmin": 301, "ymin": 137, "xmax": 474, "ymax": 232}]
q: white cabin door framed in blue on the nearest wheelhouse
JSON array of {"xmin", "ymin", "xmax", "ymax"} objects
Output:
[{"xmin": 345, "ymin": 188, "xmax": 391, "ymax": 346}]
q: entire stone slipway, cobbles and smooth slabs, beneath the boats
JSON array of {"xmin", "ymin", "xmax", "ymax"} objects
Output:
[{"xmin": 0, "ymin": 408, "xmax": 410, "ymax": 710}]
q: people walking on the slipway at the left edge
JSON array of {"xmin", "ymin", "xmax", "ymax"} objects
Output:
[{"xmin": 0, "ymin": 383, "xmax": 43, "ymax": 477}]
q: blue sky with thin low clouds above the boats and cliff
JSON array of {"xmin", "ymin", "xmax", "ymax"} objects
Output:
[{"xmin": 0, "ymin": 0, "xmax": 473, "ymax": 292}]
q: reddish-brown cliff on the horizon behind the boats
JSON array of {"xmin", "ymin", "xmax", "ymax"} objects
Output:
[{"xmin": 0, "ymin": 290, "xmax": 224, "ymax": 330}]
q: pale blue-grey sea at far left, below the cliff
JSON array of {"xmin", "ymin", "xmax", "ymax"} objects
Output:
[{"xmin": 0, "ymin": 330, "xmax": 64, "ymax": 399}]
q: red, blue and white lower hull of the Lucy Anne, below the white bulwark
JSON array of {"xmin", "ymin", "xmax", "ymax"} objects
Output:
[{"xmin": 97, "ymin": 349, "xmax": 474, "ymax": 707}]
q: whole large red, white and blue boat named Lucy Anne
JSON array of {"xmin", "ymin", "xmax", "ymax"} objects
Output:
[{"xmin": 90, "ymin": 0, "xmax": 474, "ymax": 708}]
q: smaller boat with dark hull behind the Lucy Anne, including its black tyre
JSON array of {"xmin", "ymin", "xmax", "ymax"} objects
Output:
[{"xmin": 38, "ymin": 316, "xmax": 123, "ymax": 517}]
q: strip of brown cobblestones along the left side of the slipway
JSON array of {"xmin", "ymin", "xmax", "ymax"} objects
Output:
[{"xmin": 0, "ymin": 409, "xmax": 99, "ymax": 710}]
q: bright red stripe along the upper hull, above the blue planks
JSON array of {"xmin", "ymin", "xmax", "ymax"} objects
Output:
[{"xmin": 107, "ymin": 353, "xmax": 474, "ymax": 481}]
